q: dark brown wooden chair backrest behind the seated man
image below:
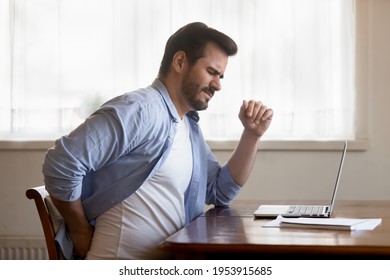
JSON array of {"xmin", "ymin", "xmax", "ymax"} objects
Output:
[{"xmin": 26, "ymin": 186, "xmax": 63, "ymax": 260}]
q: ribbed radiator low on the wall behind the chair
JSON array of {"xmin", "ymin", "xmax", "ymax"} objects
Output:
[{"xmin": 0, "ymin": 238, "xmax": 48, "ymax": 260}]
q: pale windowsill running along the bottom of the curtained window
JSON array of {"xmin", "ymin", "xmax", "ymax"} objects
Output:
[{"xmin": 0, "ymin": 139, "xmax": 369, "ymax": 151}]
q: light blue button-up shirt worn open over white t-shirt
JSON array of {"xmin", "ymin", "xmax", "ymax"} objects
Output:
[{"xmin": 42, "ymin": 79, "xmax": 244, "ymax": 255}]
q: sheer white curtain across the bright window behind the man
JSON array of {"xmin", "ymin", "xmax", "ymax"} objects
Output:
[{"xmin": 0, "ymin": 0, "xmax": 355, "ymax": 139}]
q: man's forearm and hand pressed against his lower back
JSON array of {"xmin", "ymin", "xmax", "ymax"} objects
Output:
[{"xmin": 52, "ymin": 197, "xmax": 93, "ymax": 258}]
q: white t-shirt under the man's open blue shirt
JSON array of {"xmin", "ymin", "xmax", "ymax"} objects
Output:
[{"xmin": 87, "ymin": 117, "xmax": 192, "ymax": 259}]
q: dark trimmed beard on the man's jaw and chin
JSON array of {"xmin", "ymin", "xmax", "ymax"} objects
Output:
[{"xmin": 183, "ymin": 81, "xmax": 214, "ymax": 111}]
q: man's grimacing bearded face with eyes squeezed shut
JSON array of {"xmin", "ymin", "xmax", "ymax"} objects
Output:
[{"xmin": 182, "ymin": 43, "xmax": 228, "ymax": 111}]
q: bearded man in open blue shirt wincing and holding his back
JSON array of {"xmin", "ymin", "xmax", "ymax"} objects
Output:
[{"xmin": 43, "ymin": 23, "xmax": 273, "ymax": 259}]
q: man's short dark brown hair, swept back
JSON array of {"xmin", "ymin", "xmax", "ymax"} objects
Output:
[{"xmin": 159, "ymin": 22, "xmax": 237, "ymax": 77}]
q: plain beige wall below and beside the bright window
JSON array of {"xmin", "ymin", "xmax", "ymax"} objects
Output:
[{"xmin": 0, "ymin": 0, "xmax": 390, "ymax": 238}]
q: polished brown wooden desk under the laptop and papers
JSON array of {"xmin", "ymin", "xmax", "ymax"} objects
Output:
[{"xmin": 161, "ymin": 201, "xmax": 390, "ymax": 259}]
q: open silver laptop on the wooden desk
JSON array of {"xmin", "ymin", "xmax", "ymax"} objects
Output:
[{"xmin": 253, "ymin": 141, "xmax": 347, "ymax": 218}]
